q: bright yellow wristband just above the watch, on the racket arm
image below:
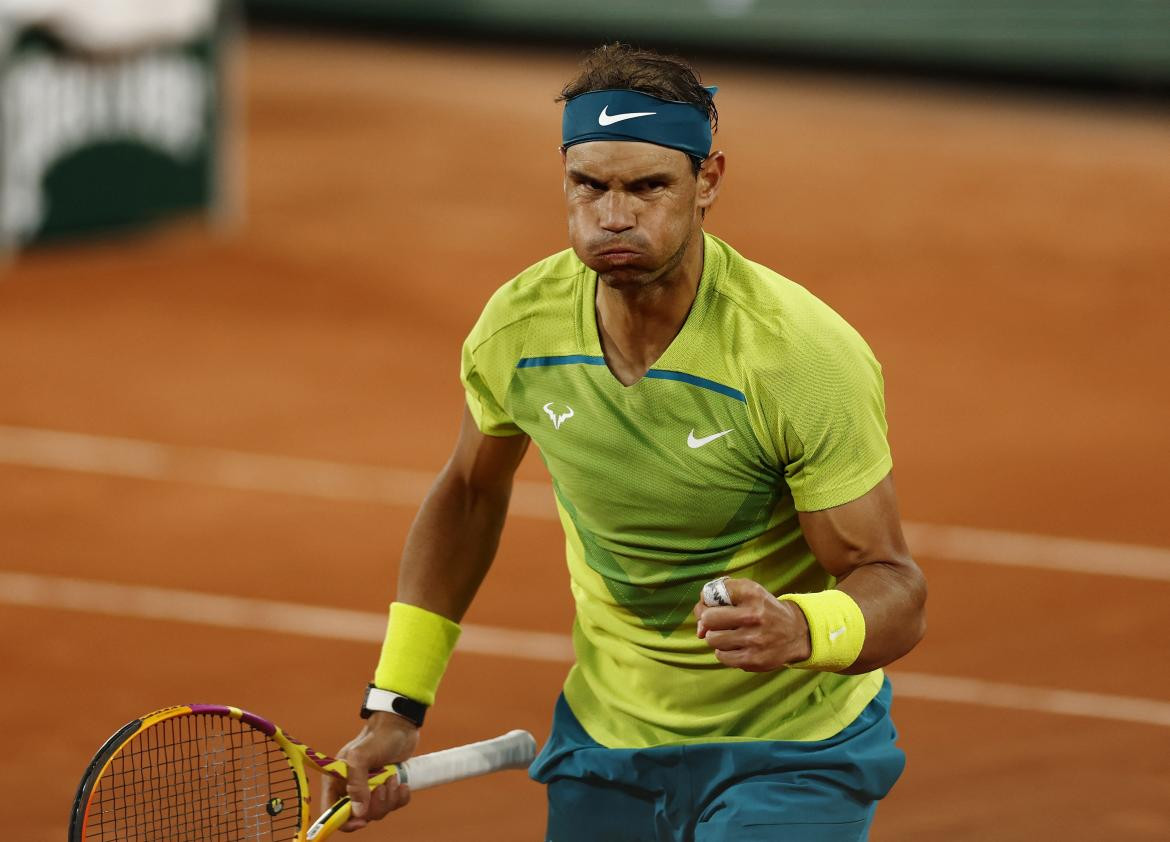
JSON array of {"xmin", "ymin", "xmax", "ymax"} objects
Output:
[{"xmin": 373, "ymin": 602, "xmax": 460, "ymax": 705}]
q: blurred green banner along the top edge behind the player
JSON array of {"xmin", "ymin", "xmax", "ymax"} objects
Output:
[{"xmin": 246, "ymin": 0, "xmax": 1170, "ymax": 85}]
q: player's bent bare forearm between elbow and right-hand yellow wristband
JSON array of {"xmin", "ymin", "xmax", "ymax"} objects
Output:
[{"xmin": 838, "ymin": 561, "xmax": 927, "ymax": 675}]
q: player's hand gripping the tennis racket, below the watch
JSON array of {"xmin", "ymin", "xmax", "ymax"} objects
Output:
[{"xmin": 322, "ymin": 712, "xmax": 419, "ymax": 833}]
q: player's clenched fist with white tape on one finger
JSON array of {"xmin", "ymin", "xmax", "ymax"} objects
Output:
[{"xmin": 695, "ymin": 579, "xmax": 812, "ymax": 672}]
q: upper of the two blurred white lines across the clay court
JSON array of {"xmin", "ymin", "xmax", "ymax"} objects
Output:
[{"xmin": 0, "ymin": 426, "xmax": 1170, "ymax": 581}]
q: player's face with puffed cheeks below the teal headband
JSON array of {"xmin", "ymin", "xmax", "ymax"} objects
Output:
[{"xmin": 564, "ymin": 140, "xmax": 715, "ymax": 287}]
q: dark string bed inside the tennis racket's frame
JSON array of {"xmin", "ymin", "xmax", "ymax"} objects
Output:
[{"xmin": 84, "ymin": 715, "xmax": 301, "ymax": 842}]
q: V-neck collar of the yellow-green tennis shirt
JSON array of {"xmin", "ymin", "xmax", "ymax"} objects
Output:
[{"xmin": 577, "ymin": 232, "xmax": 723, "ymax": 389}]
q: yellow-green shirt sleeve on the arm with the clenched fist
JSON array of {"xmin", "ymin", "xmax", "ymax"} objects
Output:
[{"xmin": 776, "ymin": 325, "xmax": 893, "ymax": 511}]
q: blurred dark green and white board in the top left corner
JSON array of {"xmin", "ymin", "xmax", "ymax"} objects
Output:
[{"xmin": 0, "ymin": 0, "xmax": 234, "ymax": 248}]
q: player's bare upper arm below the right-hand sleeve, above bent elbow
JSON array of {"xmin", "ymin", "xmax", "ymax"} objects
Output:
[{"xmin": 798, "ymin": 474, "xmax": 914, "ymax": 579}]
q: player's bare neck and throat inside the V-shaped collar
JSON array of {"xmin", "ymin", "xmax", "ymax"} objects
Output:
[{"xmin": 597, "ymin": 229, "xmax": 703, "ymax": 386}]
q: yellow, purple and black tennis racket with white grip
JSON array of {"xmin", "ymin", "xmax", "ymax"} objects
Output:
[{"xmin": 69, "ymin": 705, "xmax": 536, "ymax": 842}]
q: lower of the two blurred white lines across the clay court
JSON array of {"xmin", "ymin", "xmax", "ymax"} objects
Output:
[{"xmin": 0, "ymin": 571, "xmax": 1170, "ymax": 727}]
